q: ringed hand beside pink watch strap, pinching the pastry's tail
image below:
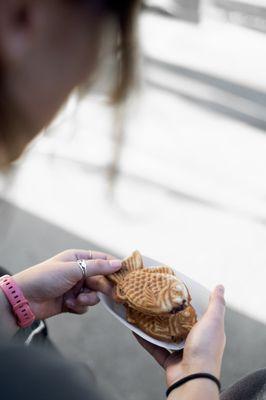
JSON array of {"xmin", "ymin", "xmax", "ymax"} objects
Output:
[{"xmin": 13, "ymin": 250, "xmax": 121, "ymax": 319}]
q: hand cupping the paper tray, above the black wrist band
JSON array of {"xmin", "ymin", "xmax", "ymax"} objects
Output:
[{"xmin": 135, "ymin": 286, "xmax": 225, "ymax": 387}]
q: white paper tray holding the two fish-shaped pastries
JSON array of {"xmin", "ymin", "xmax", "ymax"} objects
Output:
[{"xmin": 98, "ymin": 256, "xmax": 210, "ymax": 350}]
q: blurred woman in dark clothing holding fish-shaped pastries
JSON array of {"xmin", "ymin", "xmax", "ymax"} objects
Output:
[{"xmin": 0, "ymin": 0, "xmax": 264, "ymax": 400}]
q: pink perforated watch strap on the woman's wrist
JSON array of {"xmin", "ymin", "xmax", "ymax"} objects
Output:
[{"xmin": 0, "ymin": 275, "xmax": 35, "ymax": 328}]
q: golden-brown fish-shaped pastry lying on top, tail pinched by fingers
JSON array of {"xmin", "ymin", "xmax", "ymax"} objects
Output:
[{"xmin": 108, "ymin": 251, "xmax": 191, "ymax": 316}]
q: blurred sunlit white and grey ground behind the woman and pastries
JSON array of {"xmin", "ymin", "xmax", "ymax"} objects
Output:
[{"xmin": 0, "ymin": 0, "xmax": 266, "ymax": 400}]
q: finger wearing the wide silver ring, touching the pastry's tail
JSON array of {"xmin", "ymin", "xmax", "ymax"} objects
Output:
[{"xmin": 69, "ymin": 259, "xmax": 122, "ymax": 279}]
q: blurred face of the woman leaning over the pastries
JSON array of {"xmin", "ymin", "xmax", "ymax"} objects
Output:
[{"xmin": 0, "ymin": 0, "xmax": 104, "ymax": 162}]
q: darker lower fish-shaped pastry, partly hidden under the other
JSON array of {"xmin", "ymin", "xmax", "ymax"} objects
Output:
[{"xmin": 126, "ymin": 306, "xmax": 197, "ymax": 343}]
